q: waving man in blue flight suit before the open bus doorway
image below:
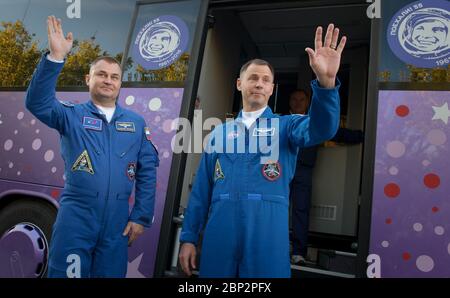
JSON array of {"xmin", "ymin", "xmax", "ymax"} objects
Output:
[{"xmin": 179, "ymin": 24, "xmax": 346, "ymax": 277}]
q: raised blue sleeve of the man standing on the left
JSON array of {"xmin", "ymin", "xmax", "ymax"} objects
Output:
[{"xmin": 25, "ymin": 55, "xmax": 69, "ymax": 134}]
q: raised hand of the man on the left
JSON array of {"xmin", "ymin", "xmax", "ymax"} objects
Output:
[{"xmin": 47, "ymin": 16, "xmax": 73, "ymax": 60}]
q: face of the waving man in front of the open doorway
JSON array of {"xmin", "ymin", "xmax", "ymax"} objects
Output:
[{"xmin": 237, "ymin": 64, "xmax": 274, "ymax": 110}]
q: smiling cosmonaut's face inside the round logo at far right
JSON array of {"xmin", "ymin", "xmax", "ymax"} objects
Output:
[{"xmin": 412, "ymin": 20, "xmax": 447, "ymax": 51}]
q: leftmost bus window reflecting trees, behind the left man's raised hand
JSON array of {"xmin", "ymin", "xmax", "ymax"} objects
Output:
[{"xmin": 0, "ymin": 0, "xmax": 136, "ymax": 87}]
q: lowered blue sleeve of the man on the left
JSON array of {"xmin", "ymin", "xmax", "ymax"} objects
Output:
[{"xmin": 129, "ymin": 123, "xmax": 159, "ymax": 227}]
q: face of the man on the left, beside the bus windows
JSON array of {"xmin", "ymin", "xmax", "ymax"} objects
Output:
[{"xmin": 86, "ymin": 60, "xmax": 122, "ymax": 102}]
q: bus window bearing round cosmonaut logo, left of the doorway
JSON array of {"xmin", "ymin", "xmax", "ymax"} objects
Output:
[{"xmin": 124, "ymin": 1, "xmax": 200, "ymax": 83}]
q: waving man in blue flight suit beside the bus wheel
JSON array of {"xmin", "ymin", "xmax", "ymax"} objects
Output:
[{"xmin": 26, "ymin": 16, "xmax": 159, "ymax": 277}]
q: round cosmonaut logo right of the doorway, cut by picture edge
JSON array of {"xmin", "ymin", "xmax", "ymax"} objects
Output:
[{"xmin": 387, "ymin": 0, "xmax": 450, "ymax": 68}]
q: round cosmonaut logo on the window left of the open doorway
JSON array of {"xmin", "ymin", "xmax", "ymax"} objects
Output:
[{"xmin": 133, "ymin": 15, "xmax": 189, "ymax": 70}]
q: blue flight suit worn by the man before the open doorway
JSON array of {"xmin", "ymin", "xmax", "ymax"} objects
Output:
[{"xmin": 180, "ymin": 81, "xmax": 339, "ymax": 277}]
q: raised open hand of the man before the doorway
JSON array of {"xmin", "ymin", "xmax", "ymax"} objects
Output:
[{"xmin": 305, "ymin": 24, "xmax": 347, "ymax": 88}]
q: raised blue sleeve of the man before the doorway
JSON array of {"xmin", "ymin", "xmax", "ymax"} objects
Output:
[{"xmin": 288, "ymin": 80, "xmax": 340, "ymax": 147}]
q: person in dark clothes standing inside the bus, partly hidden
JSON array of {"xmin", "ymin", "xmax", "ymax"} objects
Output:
[{"xmin": 289, "ymin": 89, "xmax": 364, "ymax": 265}]
